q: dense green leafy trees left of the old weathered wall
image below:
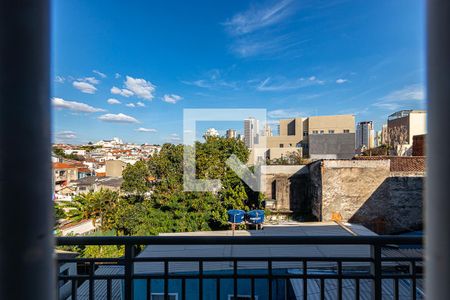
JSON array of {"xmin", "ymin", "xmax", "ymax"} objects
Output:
[{"xmin": 57, "ymin": 137, "xmax": 262, "ymax": 243}]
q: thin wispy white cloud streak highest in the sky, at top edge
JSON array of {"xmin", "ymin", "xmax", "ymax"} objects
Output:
[{"xmin": 224, "ymin": 0, "xmax": 294, "ymax": 35}]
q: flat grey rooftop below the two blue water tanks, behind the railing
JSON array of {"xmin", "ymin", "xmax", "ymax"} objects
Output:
[{"xmin": 135, "ymin": 222, "xmax": 377, "ymax": 274}]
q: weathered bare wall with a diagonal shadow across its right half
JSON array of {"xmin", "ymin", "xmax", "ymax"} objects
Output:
[{"xmin": 309, "ymin": 160, "xmax": 424, "ymax": 234}]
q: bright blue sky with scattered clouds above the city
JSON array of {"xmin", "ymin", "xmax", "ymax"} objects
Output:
[{"xmin": 52, "ymin": 0, "xmax": 426, "ymax": 144}]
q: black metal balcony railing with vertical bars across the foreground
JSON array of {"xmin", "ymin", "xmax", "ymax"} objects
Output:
[{"xmin": 56, "ymin": 236, "xmax": 424, "ymax": 300}]
